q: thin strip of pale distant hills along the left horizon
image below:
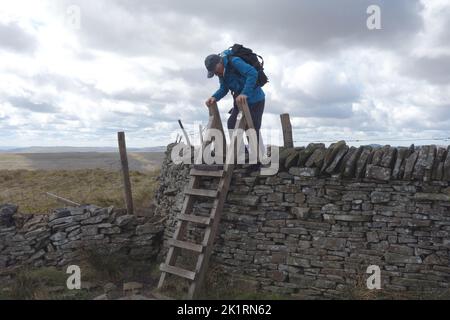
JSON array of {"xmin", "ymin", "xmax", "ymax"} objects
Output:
[{"xmin": 0, "ymin": 146, "xmax": 166, "ymax": 153}]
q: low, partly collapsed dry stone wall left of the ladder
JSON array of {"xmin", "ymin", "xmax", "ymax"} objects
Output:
[{"xmin": 0, "ymin": 204, "xmax": 163, "ymax": 271}]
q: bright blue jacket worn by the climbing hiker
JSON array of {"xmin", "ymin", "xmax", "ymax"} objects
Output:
[{"xmin": 212, "ymin": 49, "xmax": 265, "ymax": 106}]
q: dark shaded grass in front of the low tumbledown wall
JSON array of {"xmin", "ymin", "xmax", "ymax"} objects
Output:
[{"xmin": 0, "ymin": 249, "xmax": 159, "ymax": 300}]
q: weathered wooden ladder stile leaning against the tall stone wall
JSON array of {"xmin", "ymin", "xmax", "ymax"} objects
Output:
[{"xmin": 158, "ymin": 103, "xmax": 254, "ymax": 299}]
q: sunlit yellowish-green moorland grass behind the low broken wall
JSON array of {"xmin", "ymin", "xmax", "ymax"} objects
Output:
[{"xmin": 0, "ymin": 169, "xmax": 159, "ymax": 213}]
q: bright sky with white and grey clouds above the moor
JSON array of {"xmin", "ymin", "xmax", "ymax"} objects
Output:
[{"xmin": 0, "ymin": 0, "xmax": 450, "ymax": 147}]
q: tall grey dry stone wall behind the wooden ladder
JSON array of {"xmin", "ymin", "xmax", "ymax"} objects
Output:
[{"xmin": 156, "ymin": 141, "xmax": 450, "ymax": 297}]
